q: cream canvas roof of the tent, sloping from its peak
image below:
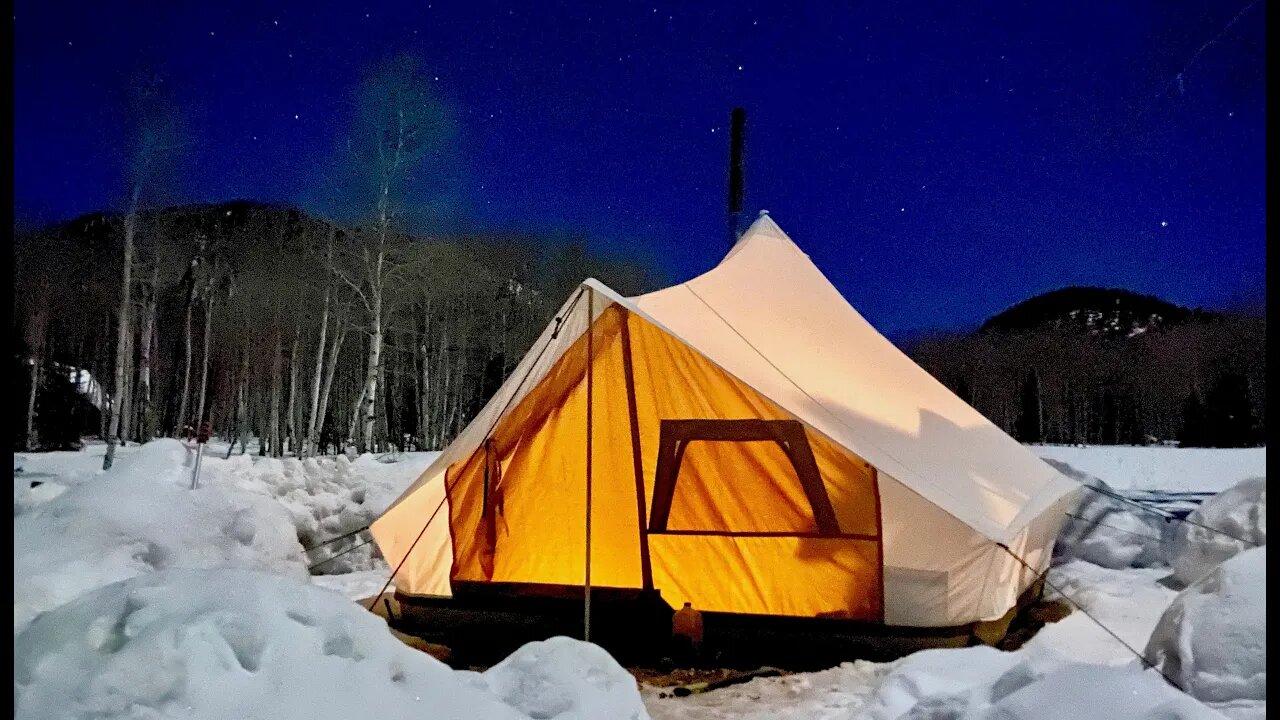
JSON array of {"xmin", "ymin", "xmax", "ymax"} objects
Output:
[{"xmin": 388, "ymin": 213, "xmax": 1078, "ymax": 542}]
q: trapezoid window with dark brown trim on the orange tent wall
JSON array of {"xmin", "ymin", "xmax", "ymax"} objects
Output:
[{"xmin": 649, "ymin": 420, "xmax": 845, "ymax": 537}]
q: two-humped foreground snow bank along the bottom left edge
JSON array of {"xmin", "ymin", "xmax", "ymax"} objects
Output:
[{"xmin": 14, "ymin": 570, "xmax": 648, "ymax": 720}]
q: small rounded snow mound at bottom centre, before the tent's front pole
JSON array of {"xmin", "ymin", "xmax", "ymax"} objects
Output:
[{"xmin": 472, "ymin": 637, "xmax": 649, "ymax": 720}]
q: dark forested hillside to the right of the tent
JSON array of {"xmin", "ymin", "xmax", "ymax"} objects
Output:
[{"xmin": 908, "ymin": 304, "xmax": 1266, "ymax": 447}]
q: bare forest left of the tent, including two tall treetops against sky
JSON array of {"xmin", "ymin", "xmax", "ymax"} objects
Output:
[{"xmin": 14, "ymin": 55, "xmax": 646, "ymax": 461}]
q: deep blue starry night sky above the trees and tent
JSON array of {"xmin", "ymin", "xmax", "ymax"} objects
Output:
[{"xmin": 13, "ymin": 0, "xmax": 1266, "ymax": 334}]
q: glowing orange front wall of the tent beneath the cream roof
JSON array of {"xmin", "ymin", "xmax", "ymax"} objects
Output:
[{"xmin": 435, "ymin": 306, "xmax": 882, "ymax": 620}]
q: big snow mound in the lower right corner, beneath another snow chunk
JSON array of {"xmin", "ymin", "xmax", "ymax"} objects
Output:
[{"xmin": 1146, "ymin": 547, "xmax": 1267, "ymax": 717}]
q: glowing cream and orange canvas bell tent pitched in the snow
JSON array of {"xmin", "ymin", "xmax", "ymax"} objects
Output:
[{"xmin": 372, "ymin": 214, "xmax": 1079, "ymax": 628}]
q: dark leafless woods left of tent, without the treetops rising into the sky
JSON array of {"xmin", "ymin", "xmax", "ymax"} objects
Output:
[{"xmin": 14, "ymin": 202, "xmax": 653, "ymax": 456}]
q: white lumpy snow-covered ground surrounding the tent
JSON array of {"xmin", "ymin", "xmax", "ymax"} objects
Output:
[{"xmin": 14, "ymin": 441, "xmax": 1266, "ymax": 720}]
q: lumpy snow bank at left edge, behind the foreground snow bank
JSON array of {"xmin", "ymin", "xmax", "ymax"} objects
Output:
[{"xmin": 13, "ymin": 439, "xmax": 307, "ymax": 633}]
